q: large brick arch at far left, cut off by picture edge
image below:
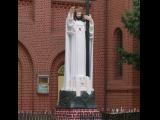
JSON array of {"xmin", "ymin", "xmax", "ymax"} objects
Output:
[{"xmin": 18, "ymin": 41, "xmax": 34, "ymax": 111}]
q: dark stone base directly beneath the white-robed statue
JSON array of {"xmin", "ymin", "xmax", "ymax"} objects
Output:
[{"xmin": 58, "ymin": 90, "xmax": 96, "ymax": 108}]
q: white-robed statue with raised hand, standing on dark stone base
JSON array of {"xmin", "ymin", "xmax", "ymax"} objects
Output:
[{"xmin": 63, "ymin": 7, "xmax": 94, "ymax": 96}]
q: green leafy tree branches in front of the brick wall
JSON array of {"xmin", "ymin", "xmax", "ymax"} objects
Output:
[{"xmin": 117, "ymin": 0, "xmax": 140, "ymax": 70}]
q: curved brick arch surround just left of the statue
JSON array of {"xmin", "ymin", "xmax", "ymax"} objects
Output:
[{"xmin": 50, "ymin": 51, "xmax": 64, "ymax": 108}]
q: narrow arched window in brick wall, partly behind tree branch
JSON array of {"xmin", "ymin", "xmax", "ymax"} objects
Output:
[{"xmin": 114, "ymin": 28, "xmax": 123, "ymax": 79}]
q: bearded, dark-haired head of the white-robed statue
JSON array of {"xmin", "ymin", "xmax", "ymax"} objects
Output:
[{"xmin": 74, "ymin": 7, "xmax": 84, "ymax": 21}]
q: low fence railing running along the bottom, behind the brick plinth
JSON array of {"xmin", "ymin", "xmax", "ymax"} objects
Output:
[{"xmin": 18, "ymin": 112, "xmax": 140, "ymax": 120}]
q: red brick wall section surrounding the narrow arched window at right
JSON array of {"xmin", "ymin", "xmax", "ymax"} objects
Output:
[{"xmin": 105, "ymin": 0, "xmax": 139, "ymax": 108}]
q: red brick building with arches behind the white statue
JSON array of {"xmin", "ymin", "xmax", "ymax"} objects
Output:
[{"xmin": 18, "ymin": 0, "xmax": 140, "ymax": 111}]
